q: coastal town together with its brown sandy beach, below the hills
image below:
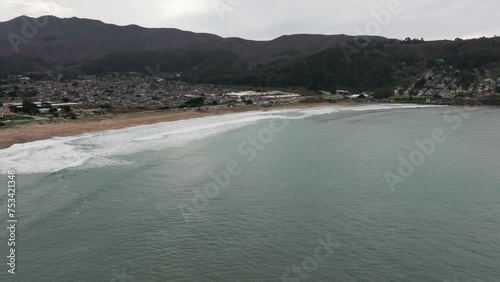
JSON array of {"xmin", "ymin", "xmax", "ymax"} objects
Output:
[{"xmin": 0, "ymin": 67, "xmax": 500, "ymax": 148}]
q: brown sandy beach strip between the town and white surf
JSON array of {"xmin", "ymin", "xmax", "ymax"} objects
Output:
[{"xmin": 0, "ymin": 103, "xmax": 338, "ymax": 149}]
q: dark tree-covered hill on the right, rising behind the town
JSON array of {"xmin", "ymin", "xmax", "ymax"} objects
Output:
[{"xmin": 187, "ymin": 38, "xmax": 500, "ymax": 90}]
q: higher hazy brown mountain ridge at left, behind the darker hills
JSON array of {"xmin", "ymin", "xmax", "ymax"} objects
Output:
[{"xmin": 0, "ymin": 16, "xmax": 376, "ymax": 65}]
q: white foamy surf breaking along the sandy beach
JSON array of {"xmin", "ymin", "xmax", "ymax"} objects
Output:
[{"xmin": 0, "ymin": 104, "xmax": 442, "ymax": 174}]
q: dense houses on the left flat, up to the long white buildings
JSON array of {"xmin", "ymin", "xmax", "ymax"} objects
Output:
[{"xmin": 0, "ymin": 73, "xmax": 300, "ymax": 118}]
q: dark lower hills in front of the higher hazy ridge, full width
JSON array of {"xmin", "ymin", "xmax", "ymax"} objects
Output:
[{"xmin": 0, "ymin": 34, "xmax": 500, "ymax": 91}]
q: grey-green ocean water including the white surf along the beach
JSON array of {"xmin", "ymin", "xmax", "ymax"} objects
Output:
[{"xmin": 0, "ymin": 104, "xmax": 500, "ymax": 282}]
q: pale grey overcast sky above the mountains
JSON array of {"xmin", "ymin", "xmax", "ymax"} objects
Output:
[{"xmin": 0, "ymin": 0, "xmax": 500, "ymax": 40}]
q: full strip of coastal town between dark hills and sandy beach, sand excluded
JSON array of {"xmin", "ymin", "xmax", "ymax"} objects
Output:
[{"xmin": 0, "ymin": 69, "xmax": 500, "ymax": 122}]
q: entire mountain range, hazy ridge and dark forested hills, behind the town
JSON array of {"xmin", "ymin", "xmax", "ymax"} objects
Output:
[{"xmin": 0, "ymin": 16, "xmax": 500, "ymax": 88}]
